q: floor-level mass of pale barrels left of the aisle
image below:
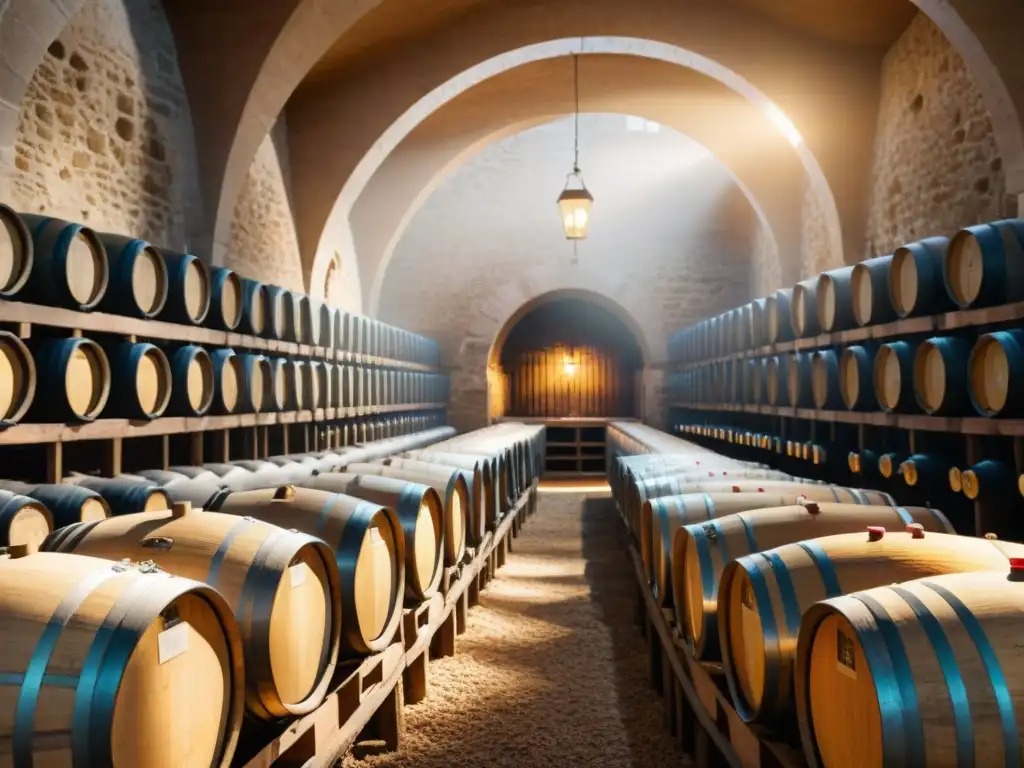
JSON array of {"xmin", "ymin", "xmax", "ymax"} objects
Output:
[{"xmin": 0, "ymin": 424, "xmax": 543, "ymax": 768}]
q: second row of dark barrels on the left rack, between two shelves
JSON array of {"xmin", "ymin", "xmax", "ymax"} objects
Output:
[{"xmin": 0, "ymin": 332, "xmax": 447, "ymax": 423}]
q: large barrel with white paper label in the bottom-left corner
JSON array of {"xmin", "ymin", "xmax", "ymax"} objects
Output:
[{"xmin": 0, "ymin": 553, "xmax": 245, "ymax": 768}]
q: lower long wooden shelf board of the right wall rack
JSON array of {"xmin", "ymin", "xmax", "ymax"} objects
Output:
[{"xmin": 670, "ymin": 402, "xmax": 1024, "ymax": 437}]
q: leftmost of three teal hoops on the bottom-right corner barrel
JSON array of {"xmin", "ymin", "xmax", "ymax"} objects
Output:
[{"xmin": 851, "ymin": 593, "xmax": 925, "ymax": 766}]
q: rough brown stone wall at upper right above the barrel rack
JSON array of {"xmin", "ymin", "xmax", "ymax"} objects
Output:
[{"xmin": 867, "ymin": 14, "xmax": 1016, "ymax": 255}]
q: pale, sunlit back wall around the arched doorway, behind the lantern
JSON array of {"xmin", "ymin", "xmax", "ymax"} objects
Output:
[{"xmin": 380, "ymin": 115, "xmax": 756, "ymax": 429}]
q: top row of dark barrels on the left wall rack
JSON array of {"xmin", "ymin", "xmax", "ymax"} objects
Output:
[{"xmin": 0, "ymin": 205, "xmax": 438, "ymax": 368}]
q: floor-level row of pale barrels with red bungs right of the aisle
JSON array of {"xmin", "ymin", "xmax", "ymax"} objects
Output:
[{"xmin": 608, "ymin": 424, "xmax": 1024, "ymax": 766}]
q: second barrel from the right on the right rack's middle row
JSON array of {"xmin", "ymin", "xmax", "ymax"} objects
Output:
[{"xmin": 913, "ymin": 336, "xmax": 971, "ymax": 416}]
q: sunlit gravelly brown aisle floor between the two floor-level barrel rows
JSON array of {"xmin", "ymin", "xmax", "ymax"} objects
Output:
[{"xmin": 342, "ymin": 489, "xmax": 687, "ymax": 768}]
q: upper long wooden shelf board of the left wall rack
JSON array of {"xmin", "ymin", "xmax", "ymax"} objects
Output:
[{"xmin": 0, "ymin": 301, "xmax": 437, "ymax": 373}]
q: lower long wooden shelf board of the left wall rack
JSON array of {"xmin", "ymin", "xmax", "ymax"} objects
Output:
[{"xmin": 0, "ymin": 402, "xmax": 447, "ymax": 445}]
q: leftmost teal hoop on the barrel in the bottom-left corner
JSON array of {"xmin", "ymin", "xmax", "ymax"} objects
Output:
[{"xmin": 7, "ymin": 567, "xmax": 119, "ymax": 768}]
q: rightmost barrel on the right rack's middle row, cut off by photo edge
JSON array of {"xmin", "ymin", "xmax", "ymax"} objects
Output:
[{"xmin": 968, "ymin": 328, "xmax": 1024, "ymax": 416}]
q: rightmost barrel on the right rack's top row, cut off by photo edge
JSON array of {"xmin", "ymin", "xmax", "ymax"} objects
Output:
[{"xmin": 942, "ymin": 219, "xmax": 1024, "ymax": 308}]
